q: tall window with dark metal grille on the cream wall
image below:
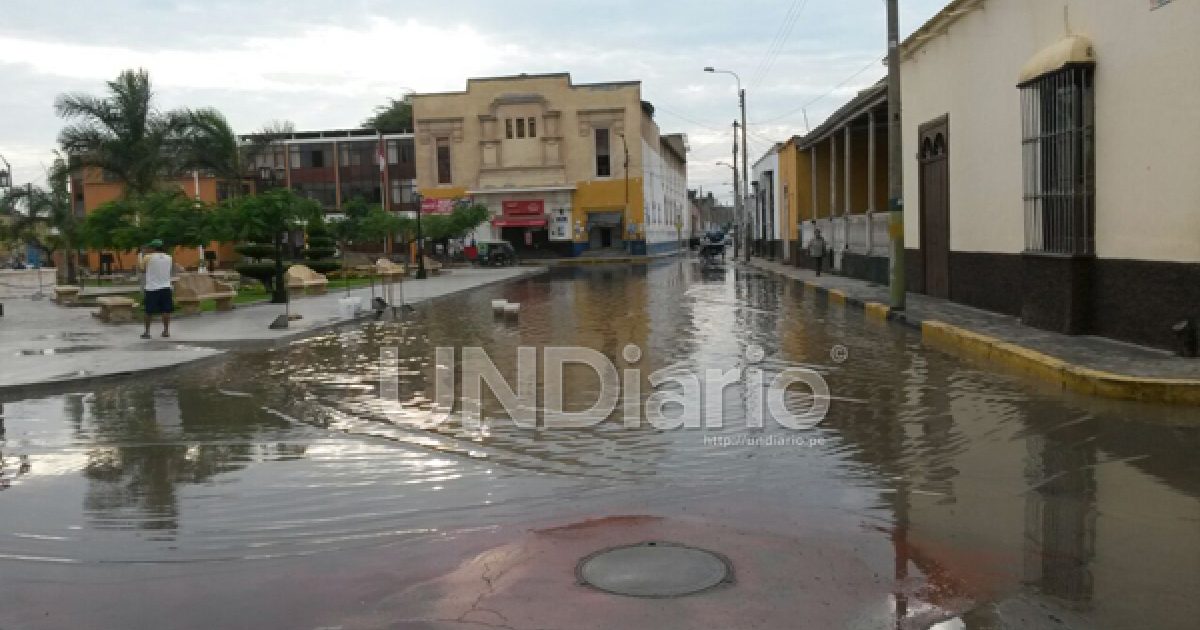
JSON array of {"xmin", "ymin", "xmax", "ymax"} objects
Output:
[{"xmin": 1020, "ymin": 65, "xmax": 1096, "ymax": 256}]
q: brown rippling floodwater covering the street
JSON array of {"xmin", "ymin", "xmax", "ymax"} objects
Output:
[{"xmin": 0, "ymin": 260, "xmax": 1200, "ymax": 630}]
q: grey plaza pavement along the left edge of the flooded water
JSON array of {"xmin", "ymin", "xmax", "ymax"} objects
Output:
[{"xmin": 0, "ymin": 268, "xmax": 546, "ymax": 391}]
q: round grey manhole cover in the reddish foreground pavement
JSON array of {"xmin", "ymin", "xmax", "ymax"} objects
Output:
[{"xmin": 576, "ymin": 542, "xmax": 733, "ymax": 598}]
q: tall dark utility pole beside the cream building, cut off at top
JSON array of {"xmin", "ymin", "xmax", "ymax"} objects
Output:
[{"xmin": 887, "ymin": 0, "xmax": 905, "ymax": 311}]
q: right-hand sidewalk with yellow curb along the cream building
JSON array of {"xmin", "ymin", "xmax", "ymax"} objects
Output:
[{"xmin": 750, "ymin": 259, "xmax": 1200, "ymax": 404}]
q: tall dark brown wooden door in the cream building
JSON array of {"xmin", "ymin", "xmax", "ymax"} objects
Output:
[{"xmin": 918, "ymin": 116, "xmax": 950, "ymax": 298}]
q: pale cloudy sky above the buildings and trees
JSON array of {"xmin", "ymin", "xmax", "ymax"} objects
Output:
[{"xmin": 0, "ymin": 0, "xmax": 944, "ymax": 198}]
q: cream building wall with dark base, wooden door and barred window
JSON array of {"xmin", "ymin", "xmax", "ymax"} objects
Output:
[{"xmin": 901, "ymin": 0, "xmax": 1200, "ymax": 347}]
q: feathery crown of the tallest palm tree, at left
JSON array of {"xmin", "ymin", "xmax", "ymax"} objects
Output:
[{"xmin": 54, "ymin": 70, "xmax": 188, "ymax": 197}]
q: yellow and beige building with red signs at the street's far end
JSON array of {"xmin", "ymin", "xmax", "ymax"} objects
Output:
[{"xmin": 413, "ymin": 73, "xmax": 689, "ymax": 256}]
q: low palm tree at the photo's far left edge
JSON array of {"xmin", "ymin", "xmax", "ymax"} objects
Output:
[{"xmin": 0, "ymin": 151, "xmax": 79, "ymax": 284}]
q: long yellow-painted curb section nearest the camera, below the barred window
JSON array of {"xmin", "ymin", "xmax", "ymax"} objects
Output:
[{"xmin": 920, "ymin": 320, "xmax": 1200, "ymax": 404}]
